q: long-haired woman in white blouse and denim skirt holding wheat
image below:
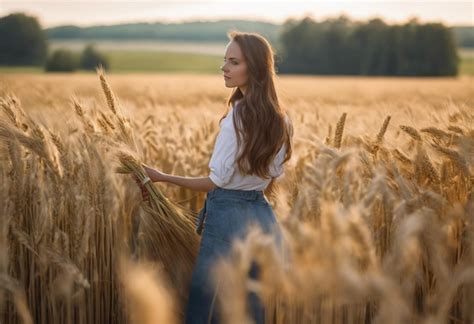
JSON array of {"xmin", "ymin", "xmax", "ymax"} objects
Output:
[{"xmin": 135, "ymin": 32, "xmax": 293, "ymax": 323}]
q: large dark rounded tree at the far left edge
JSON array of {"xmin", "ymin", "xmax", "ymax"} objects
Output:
[{"xmin": 0, "ymin": 13, "xmax": 48, "ymax": 65}]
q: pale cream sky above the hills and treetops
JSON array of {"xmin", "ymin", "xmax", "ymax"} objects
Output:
[{"xmin": 0, "ymin": 0, "xmax": 474, "ymax": 27}]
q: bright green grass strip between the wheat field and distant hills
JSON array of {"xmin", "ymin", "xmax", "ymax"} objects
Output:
[{"xmin": 0, "ymin": 49, "xmax": 474, "ymax": 75}]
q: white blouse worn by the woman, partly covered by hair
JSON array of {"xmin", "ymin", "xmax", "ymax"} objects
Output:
[{"xmin": 209, "ymin": 102, "xmax": 286, "ymax": 190}]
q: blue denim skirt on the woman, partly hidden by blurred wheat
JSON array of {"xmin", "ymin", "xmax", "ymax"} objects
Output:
[{"xmin": 185, "ymin": 188, "xmax": 281, "ymax": 324}]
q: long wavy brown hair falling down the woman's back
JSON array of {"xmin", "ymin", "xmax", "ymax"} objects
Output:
[{"xmin": 221, "ymin": 31, "xmax": 293, "ymax": 179}]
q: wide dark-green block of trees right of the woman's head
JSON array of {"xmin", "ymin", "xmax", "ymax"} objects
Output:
[{"xmin": 278, "ymin": 16, "xmax": 459, "ymax": 76}]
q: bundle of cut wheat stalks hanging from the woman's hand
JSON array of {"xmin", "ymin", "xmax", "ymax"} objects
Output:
[{"xmin": 117, "ymin": 152, "xmax": 199, "ymax": 307}]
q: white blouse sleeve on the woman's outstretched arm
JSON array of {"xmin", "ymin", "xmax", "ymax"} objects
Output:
[{"xmin": 209, "ymin": 123, "xmax": 237, "ymax": 187}]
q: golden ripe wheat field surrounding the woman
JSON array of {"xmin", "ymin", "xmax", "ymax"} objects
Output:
[{"xmin": 0, "ymin": 71, "xmax": 474, "ymax": 324}]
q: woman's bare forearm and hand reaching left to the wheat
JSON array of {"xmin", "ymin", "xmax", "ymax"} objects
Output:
[{"xmin": 143, "ymin": 165, "xmax": 217, "ymax": 192}]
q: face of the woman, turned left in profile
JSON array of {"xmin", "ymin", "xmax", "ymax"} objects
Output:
[{"xmin": 221, "ymin": 40, "xmax": 248, "ymax": 92}]
